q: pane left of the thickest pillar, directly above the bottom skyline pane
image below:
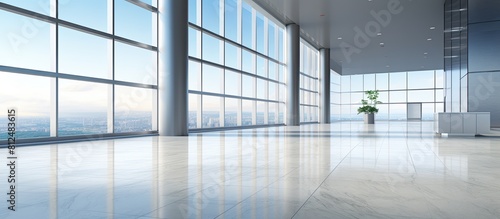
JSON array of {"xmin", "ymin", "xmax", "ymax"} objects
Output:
[{"xmin": 115, "ymin": 42, "xmax": 157, "ymax": 85}]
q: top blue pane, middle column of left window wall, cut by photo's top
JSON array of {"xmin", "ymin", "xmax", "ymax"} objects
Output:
[{"xmin": 58, "ymin": 0, "xmax": 112, "ymax": 33}]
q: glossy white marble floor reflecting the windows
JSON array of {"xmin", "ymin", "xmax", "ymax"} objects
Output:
[{"xmin": 0, "ymin": 122, "xmax": 500, "ymax": 219}]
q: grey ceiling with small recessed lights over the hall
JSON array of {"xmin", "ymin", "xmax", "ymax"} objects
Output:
[{"xmin": 253, "ymin": 0, "xmax": 444, "ymax": 75}]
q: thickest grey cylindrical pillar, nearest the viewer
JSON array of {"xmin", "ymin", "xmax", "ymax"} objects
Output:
[{"xmin": 158, "ymin": 0, "xmax": 188, "ymax": 136}]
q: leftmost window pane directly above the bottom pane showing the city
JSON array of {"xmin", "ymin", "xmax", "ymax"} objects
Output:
[{"xmin": 0, "ymin": 10, "xmax": 55, "ymax": 71}]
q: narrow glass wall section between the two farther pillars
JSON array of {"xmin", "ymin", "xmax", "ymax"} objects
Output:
[{"xmin": 300, "ymin": 39, "xmax": 319, "ymax": 123}]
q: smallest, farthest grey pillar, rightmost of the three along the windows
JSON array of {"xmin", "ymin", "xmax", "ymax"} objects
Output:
[{"xmin": 319, "ymin": 48, "xmax": 330, "ymax": 124}]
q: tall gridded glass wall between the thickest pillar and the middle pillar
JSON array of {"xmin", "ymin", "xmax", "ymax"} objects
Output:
[{"xmin": 188, "ymin": 0, "xmax": 285, "ymax": 129}]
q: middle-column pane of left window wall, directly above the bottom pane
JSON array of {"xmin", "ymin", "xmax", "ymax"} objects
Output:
[{"xmin": 59, "ymin": 27, "xmax": 111, "ymax": 79}]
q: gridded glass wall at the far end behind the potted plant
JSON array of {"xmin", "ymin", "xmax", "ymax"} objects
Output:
[{"xmin": 331, "ymin": 70, "xmax": 444, "ymax": 121}]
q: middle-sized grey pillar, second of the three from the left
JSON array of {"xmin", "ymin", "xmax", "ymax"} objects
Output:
[{"xmin": 286, "ymin": 24, "xmax": 300, "ymax": 126}]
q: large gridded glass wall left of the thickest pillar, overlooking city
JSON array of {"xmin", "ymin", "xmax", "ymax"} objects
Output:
[{"xmin": 0, "ymin": 0, "xmax": 158, "ymax": 139}]
